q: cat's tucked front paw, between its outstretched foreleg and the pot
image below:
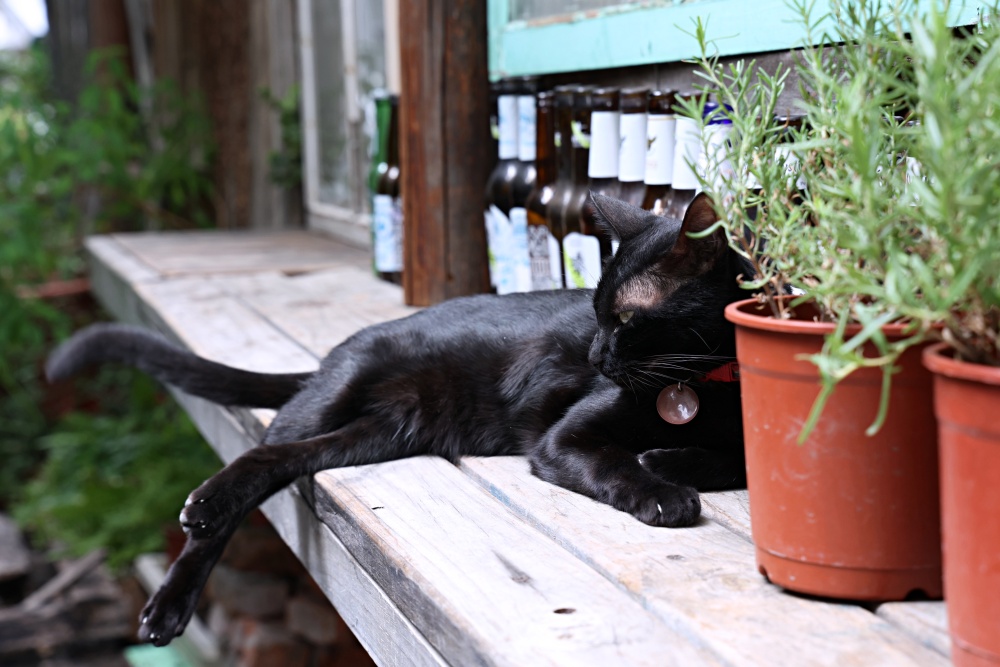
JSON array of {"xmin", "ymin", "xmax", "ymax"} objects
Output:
[{"xmin": 639, "ymin": 447, "xmax": 747, "ymax": 491}]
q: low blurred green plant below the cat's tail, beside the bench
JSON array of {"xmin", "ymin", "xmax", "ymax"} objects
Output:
[{"xmin": 14, "ymin": 370, "xmax": 220, "ymax": 568}]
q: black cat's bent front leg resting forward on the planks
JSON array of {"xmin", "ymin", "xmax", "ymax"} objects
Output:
[{"xmin": 529, "ymin": 386, "xmax": 701, "ymax": 527}]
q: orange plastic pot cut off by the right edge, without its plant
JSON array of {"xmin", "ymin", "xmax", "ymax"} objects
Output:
[{"xmin": 924, "ymin": 344, "xmax": 1000, "ymax": 667}]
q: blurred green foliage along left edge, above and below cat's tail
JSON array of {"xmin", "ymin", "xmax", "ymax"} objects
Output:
[{"xmin": 0, "ymin": 46, "xmax": 218, "ymax": 564}]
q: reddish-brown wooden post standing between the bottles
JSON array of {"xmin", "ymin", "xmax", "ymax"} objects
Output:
[{"xmin": 399, "ymin": 0, "xmax": 495, "ymax": 306}]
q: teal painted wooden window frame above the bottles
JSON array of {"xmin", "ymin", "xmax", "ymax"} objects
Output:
[{"xmin": 489, "ymin": 0, "xmax": 979, "ymax": 80}]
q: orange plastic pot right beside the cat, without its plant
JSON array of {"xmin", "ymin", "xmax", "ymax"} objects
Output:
[{"xmin": 726, "ymin": 300, "xmax": 942, "ymax": 600}]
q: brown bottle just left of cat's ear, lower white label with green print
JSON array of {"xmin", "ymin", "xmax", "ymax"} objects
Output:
[{"xmin": 563, "ymin": 86, "xmax": 600, "ymax": 288}]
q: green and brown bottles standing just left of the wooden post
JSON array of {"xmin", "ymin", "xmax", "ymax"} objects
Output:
[{"xmin": 368, "ymin": 95, "xmax": 403, "ymax": 284}]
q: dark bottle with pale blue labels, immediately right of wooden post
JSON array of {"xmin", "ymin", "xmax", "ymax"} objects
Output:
[{"xmin": 484, "ymin": 80, "xmax": 518, "ymax": 293}]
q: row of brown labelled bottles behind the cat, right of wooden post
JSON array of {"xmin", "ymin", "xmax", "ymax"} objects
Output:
[{"xmin": 485, "ymin": 83, "xmax": 701, "ymax": 294}]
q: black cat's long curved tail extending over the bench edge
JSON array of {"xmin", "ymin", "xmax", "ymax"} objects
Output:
[{"xmin": 45, "ymin": 324, "xmax": 312, "ymax": 408}]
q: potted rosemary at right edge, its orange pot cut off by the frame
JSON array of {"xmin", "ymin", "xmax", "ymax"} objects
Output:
[{"xmin": 868, "ymin": 7, "xmax": 1000, "ymax": 666}]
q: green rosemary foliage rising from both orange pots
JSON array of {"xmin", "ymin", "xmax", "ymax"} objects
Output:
[{"xmin": 684, "ymin": 0, "xmax": 1000, "ymax": 439}]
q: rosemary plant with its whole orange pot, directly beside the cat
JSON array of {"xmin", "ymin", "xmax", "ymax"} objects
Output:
[{"xmin": 685, "ymin": 0, "xmax": 960, "ymax": 600}]
